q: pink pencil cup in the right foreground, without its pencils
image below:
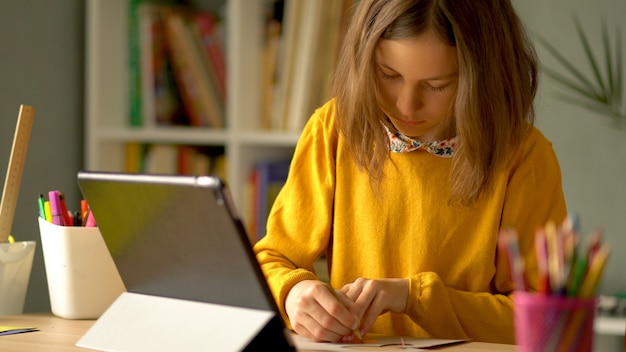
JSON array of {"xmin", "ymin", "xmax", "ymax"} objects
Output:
[{"xmin": 513, "ymin": 292, "xmax": 596, "ymax": 352}]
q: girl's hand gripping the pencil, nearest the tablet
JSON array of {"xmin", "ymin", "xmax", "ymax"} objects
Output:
[{"xmin": 285, "ymin": 280, "xmax": 359, "ymax": 342}]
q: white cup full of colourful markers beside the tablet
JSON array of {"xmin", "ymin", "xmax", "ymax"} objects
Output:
[{"xmin": 39, "ymin": 218, "xmax": 125, "ymax": 319}]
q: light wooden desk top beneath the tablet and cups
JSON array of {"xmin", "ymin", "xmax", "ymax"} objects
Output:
[{"xmin": 0, "ymin": 313, "xmax": 516, "ymax": 352}]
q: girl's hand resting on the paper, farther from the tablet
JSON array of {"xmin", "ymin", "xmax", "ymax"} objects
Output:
[{"xmin": 341, "ymin": 278, "xmax": 409, "ymax": 335}]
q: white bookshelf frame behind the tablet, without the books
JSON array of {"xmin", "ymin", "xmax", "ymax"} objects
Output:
[{"xmin": 85, "ymin": 0, "xmax": 299, "ymax": 212}]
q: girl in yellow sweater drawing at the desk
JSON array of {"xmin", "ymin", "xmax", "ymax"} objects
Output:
[{"xmin": 255, "ymin": 0, "xmax": 566, "ymax": 343}]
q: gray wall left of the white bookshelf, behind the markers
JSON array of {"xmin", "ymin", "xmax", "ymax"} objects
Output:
[{"xmin": 0, "ymin": 0, "xmax": 85, "ymax": 312}]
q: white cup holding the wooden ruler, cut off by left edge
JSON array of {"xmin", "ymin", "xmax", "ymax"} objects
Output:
[{"xmin": 0, "ymin": 241, "xmax": 36, "ymax": 315}]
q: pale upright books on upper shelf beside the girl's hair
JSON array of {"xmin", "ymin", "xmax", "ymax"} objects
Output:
[{"xmin": 261, "ymin": 0, "xmax": 356, "ymax": 132}]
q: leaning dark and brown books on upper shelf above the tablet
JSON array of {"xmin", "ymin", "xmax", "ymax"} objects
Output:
[{"xmin": 129, "ymin": 1, "xmax": 226, "ymax": 128}]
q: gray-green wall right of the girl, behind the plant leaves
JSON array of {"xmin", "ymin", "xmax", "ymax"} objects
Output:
[{"xmin": 514, "ymin": 0, "xmax": 626, "ymax": 294}]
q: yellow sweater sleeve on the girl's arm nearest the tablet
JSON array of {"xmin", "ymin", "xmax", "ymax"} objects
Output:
[{"xmin": 254, "ymin": 102, "xmax": 337, "ymax": 326}]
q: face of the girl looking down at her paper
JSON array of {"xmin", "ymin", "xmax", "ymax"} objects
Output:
[{"xmin": 375, "ymin": 33, "xmax": 459, "ymax": 142}]
